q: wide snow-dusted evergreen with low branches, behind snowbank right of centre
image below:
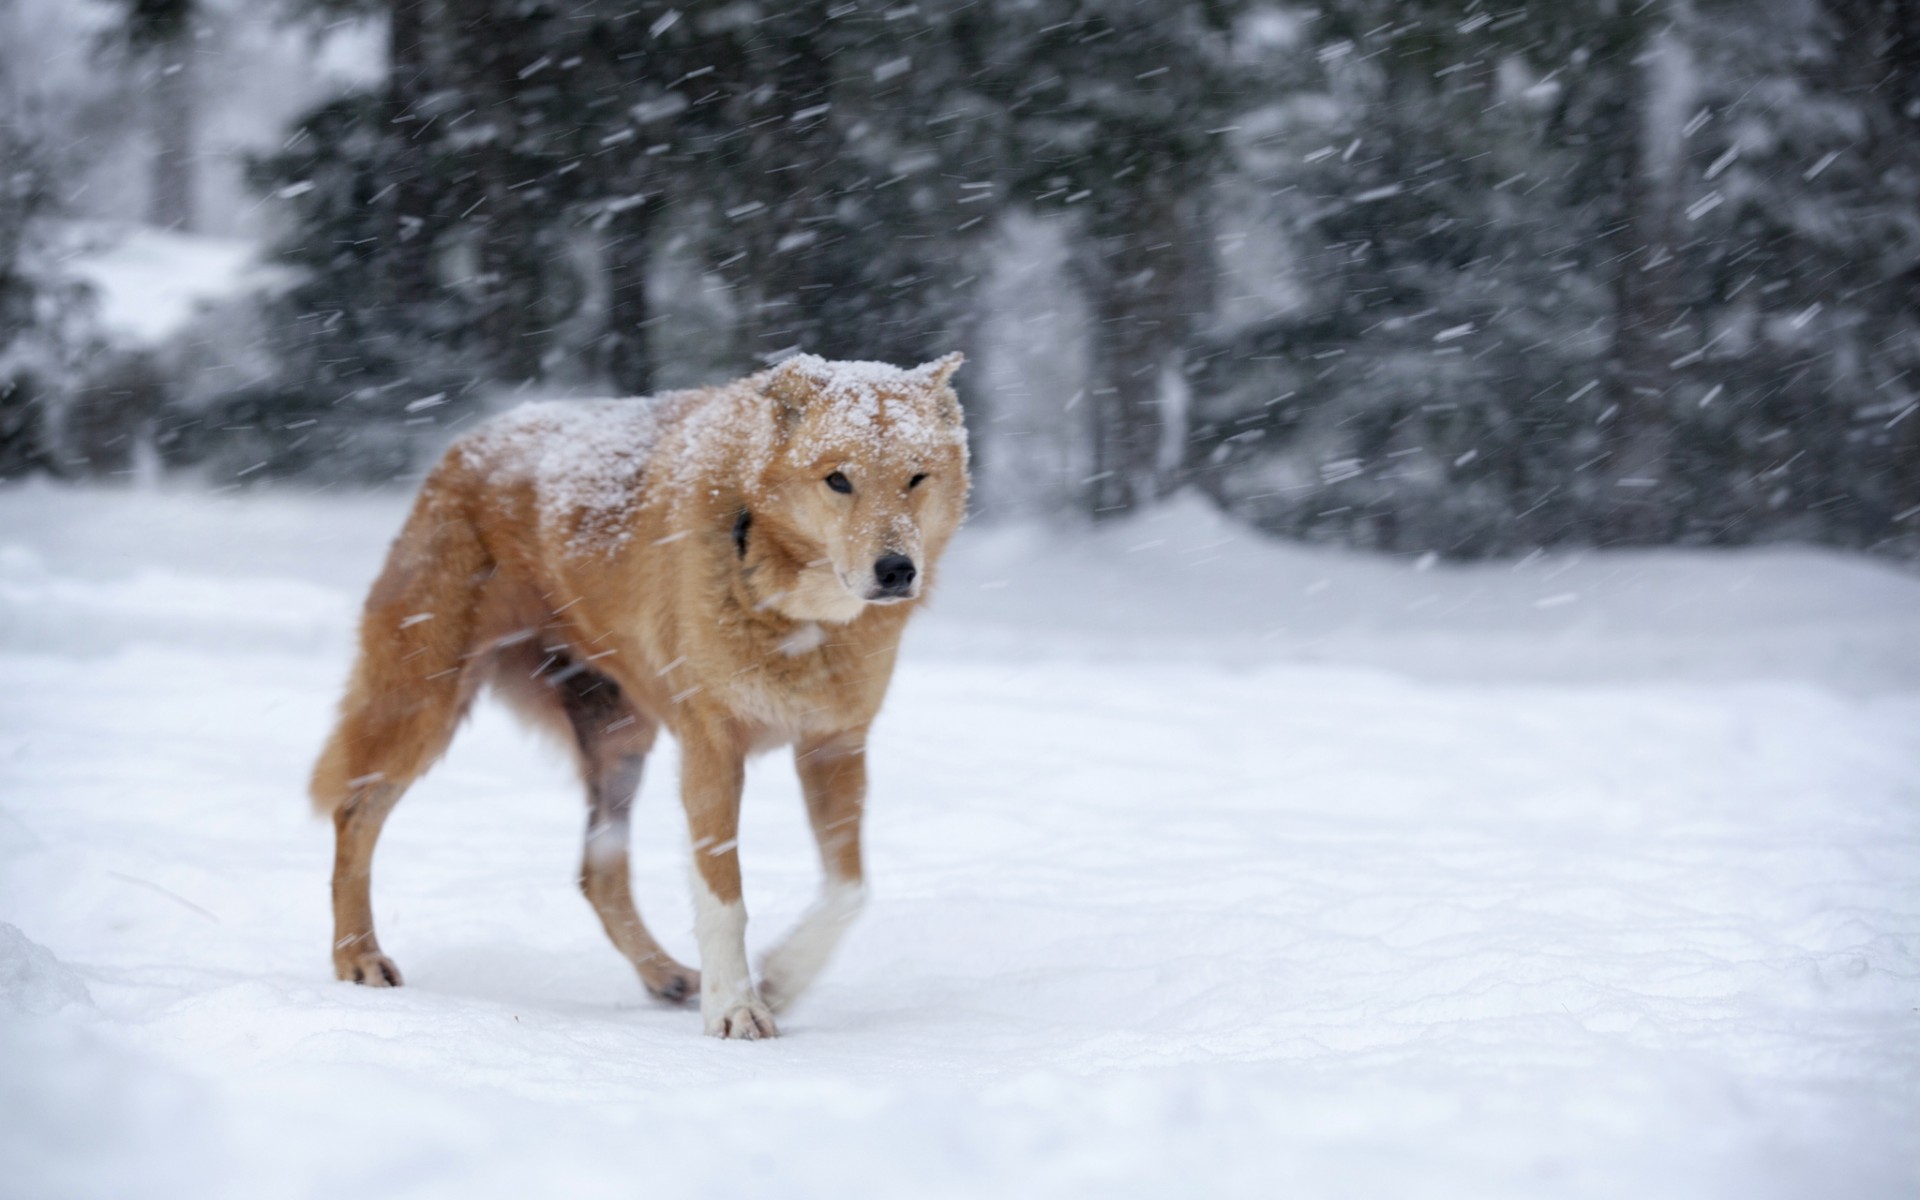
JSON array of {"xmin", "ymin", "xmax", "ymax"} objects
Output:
[{"xmin": 1192, "ymin": 6, "xmax": 1611, "ymax": 553}]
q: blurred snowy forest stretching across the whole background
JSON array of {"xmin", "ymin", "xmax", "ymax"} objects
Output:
[{"xmin": 0, "ymin": 0, "xmax": 1920, "ymax": 559}]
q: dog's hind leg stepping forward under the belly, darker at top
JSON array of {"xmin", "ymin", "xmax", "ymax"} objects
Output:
[{"xmin": 545, "ymin": 657, "xmax": 701, "ymax": 1004}]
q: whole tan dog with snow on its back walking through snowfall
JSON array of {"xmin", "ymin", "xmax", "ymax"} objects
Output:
[{"xmin": 313, "ymin": 355, "xmax": 968, "ymax": 1037}]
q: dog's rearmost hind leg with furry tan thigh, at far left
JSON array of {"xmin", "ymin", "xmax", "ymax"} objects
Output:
[{"xmin": 311, "ymin": 484, "xmax": 492, "ymax": 987}]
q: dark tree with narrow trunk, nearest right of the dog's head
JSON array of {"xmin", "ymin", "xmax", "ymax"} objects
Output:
[{"xmin": 981, "ymin": 0, "xmax": 1238, "ymax": 516}]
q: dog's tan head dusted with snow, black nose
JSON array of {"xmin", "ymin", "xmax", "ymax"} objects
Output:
[{"xmin": 751, "ymin": 353, "xmax": 968, "ymax": 620}]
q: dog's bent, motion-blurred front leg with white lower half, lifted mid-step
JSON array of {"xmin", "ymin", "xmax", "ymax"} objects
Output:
[{"xmin": 760, "ymin": 730, "xmax": 866, "ymax": 1012}]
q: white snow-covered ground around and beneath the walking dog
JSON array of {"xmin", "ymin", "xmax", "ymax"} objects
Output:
[{"xmin": 0, "ymin": 488, "xmax": 1920, "ymax": 1200}]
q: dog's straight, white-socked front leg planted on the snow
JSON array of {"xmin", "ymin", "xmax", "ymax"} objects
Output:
[{"xmin": 680, "ymin": 728, "xmax": 780, "ymax": 1039}]
